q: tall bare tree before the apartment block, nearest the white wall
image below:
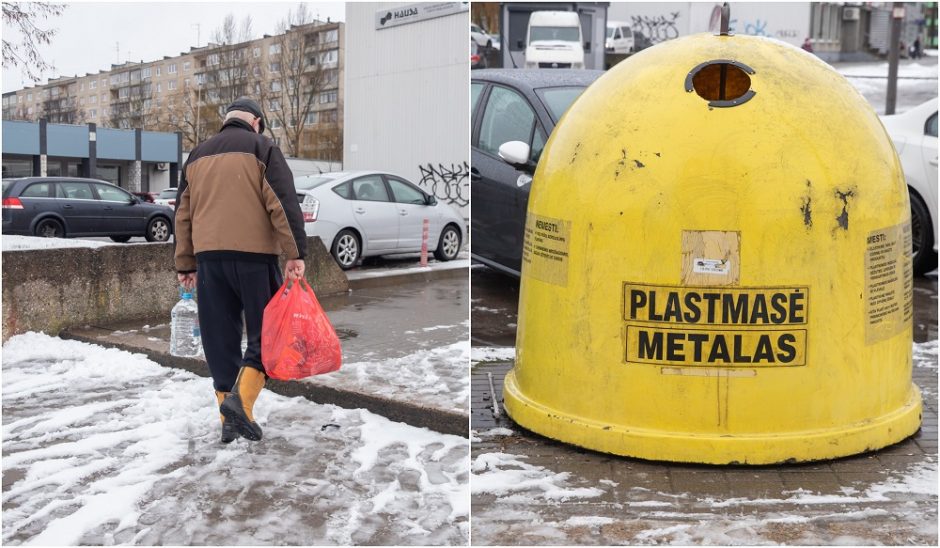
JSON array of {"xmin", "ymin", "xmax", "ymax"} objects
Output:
[{"xmin": 265, "ymin": 4, "xmax": 338, "ymax": 157}]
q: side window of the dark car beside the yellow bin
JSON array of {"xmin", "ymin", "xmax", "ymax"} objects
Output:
[{"xmin": 479, "ymin": 86, "xmax": 535, "ymax": 154}]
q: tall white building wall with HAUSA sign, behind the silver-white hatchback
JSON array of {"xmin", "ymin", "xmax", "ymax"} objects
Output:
[{"xmin": 343, "ymin": 2, "xmax": 470, "ymax": 218}]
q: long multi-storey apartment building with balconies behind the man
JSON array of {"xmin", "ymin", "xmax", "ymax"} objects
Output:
[{"xmin": 2, "ymin": 21, "xmax": 345, "ymax": 161}]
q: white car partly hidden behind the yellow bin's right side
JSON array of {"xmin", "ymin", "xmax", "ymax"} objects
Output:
[{"xmin": 881, "ymin": 97, "xmax": 938, "ymax": 275}]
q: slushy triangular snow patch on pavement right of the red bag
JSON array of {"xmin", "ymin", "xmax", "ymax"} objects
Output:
[{"xmin": 309, "ymin": 340, "xmax": 470, "ymax": 413}]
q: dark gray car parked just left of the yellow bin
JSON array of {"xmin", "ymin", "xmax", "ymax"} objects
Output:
[{"xmin": 470, "ymin": 69, "xmax": 604, "ymax": 276}]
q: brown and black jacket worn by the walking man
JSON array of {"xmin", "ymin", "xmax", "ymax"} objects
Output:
[{"xmin": 175, "ymin": 118, "xmax": 307, "ymax": 273}]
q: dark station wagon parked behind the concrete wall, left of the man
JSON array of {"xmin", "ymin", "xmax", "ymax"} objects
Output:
[{"xmin": 2, "ymin": 177, "xmax": 173, "ymax": 242}]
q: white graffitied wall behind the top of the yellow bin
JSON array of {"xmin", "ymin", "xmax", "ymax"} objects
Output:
[{"xmin": 607, "ymin": 2, "xmax": 810, "ymax": 47}]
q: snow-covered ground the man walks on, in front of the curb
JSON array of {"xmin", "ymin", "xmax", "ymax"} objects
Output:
[{"xmin": 2, "ymin": 333, "xmax": 469, "ymax": 545}]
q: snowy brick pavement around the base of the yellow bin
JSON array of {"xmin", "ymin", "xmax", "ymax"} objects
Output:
[{"xmin": 470, "ymin": 340, "xmax": 938, "ymax": 546}]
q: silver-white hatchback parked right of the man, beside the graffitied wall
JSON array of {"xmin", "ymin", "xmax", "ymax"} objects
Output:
[{"xmin": 294, "ymin": 171, "xmax": 465, "ymax": 270}]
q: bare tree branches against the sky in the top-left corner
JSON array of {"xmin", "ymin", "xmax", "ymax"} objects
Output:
[{"xmin": 3, "ymin": 2, "xmax": 66, "ymax": 82}]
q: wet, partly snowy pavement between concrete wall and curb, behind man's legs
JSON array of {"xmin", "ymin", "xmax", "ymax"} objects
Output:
[{"xmin": 63, "ymin": 277, "xmax": 470, "ymax": 435}]
